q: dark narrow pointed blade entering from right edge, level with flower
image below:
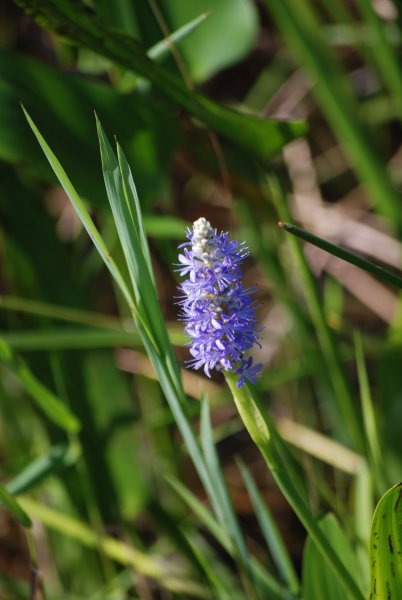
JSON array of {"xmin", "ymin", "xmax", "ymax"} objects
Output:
[{"xmin": 278, "ymin": 221, "xmax": 402, "ymax": 289}]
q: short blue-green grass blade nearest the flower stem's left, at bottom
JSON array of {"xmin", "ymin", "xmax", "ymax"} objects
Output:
[{"xmin": 237, "ymin": 460, "xmax": 300, "ymax": 595}]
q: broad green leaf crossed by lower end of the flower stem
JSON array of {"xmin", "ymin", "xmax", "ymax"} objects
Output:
[{"xmin": 303, "ymin": 514, "xmax": 360, "ymax": 600}]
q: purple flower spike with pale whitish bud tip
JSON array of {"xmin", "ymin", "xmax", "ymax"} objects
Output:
[{"xmin": 178, "ymin": 218, "xmax": 262, "ymax": 388}]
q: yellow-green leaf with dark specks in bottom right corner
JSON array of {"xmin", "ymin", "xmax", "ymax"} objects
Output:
[{"xmin": 370, "ymin": 483, "xmax": 402, "ymax": 600}]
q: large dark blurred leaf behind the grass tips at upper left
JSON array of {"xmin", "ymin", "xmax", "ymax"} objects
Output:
[{"xmin": 0, "ymin": 48, "xmax": 173, "ymax": 208}]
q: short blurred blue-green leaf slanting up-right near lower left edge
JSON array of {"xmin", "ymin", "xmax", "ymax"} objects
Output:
[{"xmin": 5, "ymin": 445, "xmax": 79, "ymax": 496}]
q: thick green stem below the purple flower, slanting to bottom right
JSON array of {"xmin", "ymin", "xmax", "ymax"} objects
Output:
[{"xmin": 225, "ymin": 373, "xmax": 364, "ymax": 600}]
